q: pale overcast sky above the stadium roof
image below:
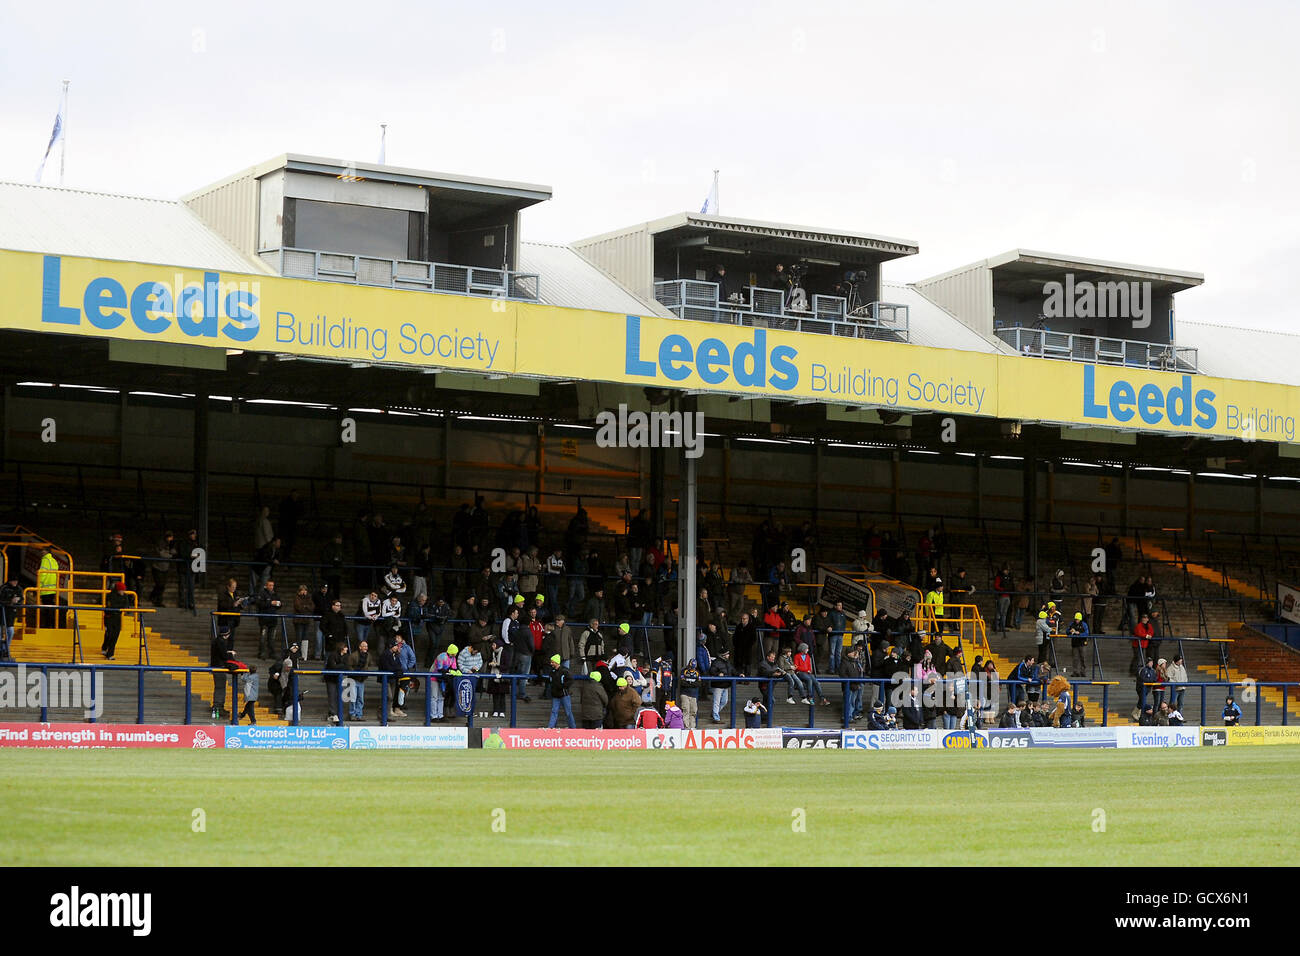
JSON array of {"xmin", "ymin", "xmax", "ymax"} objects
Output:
[{"xmin": 0, "ymin": 0, "xmax": 1300, "ymax": 330}]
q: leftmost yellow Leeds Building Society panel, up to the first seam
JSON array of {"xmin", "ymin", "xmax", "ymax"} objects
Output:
[{"xmin": 0, "ymin": 252, "xmax": 515, "ymax": 373}]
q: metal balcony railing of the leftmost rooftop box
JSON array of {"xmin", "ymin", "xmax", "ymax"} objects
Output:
[{"xmin": 257, "ymin": 248, "xmax": 541, "ymax": 302}]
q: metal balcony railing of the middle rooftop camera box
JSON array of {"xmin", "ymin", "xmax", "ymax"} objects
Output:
[{"xmin": 654, "ymin": 278, "xmax": 911, "ymax": 342}]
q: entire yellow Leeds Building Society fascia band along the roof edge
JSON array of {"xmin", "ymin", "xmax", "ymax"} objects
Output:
[{"xmin": 0, "ymin": 244, "xmax": 1300, "ymax": 442}]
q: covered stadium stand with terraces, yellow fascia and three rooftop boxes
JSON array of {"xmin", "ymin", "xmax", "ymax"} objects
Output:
[{"xmin": 0, "ymin": 155, "xmax": 1300, "ymax": 726}]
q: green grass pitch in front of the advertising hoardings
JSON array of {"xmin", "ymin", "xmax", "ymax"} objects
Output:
[{"xmin": 0, "ymin": 747, "xmax": 1300, "ymax": 866}]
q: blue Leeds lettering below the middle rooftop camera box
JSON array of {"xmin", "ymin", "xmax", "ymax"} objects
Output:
[{"xmin": 623, "ymin": 315, "xmax": 800, "ymax": 392}]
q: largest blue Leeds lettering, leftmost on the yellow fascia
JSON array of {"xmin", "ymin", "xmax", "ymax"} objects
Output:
[{"xmin": 40, "ymin": 256, "xmax": 260, "ymax": 342}]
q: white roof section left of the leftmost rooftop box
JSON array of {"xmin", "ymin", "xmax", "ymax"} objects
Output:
[{"xmin": 0, "ymin": 182, "xmax": 269, "ymax": 274}]
